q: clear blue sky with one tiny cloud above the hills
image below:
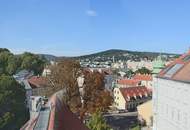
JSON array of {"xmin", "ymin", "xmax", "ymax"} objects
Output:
[{"xmin": 0, "ymin": 0, "xmax": 190, "ymax": 56}]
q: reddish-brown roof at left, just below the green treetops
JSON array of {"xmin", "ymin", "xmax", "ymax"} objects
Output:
[{"xmin": 28, "ymin": 76, "xmax": 48, "ymax": 88}]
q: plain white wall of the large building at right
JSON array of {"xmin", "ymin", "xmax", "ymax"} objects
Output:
[{"xmin": 153, "ymin": 78, "xmax": 190, "ymax": 130}]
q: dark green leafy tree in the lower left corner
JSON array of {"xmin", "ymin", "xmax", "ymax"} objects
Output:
[{"xmin": 0, "ymin": 75, "xmax": 28, "ymax": 130}]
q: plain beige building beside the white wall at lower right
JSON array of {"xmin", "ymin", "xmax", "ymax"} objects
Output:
[{"xmin": 137, "ymin": 100, "xmax": 153, "ymax": 128}]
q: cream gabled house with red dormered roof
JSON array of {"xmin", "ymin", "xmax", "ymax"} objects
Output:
[{"xmin": 114, "ymin": 86, "xmax": 152, "ymax": 110}]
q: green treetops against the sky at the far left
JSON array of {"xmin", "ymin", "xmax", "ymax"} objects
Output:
[{"xmin": 0, "ymin": 48, "xmax": 46, "ymax": 75}]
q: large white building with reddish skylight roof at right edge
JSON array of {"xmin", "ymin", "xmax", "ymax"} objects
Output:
[{"xmin": 153, "ymin": 51, "xmax": 190, "ymax": 130}]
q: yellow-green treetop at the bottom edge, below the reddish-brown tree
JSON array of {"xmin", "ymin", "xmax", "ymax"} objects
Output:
[{"xmin": 87, "ymin": 112, "xmax": 112, "ymax": 130}]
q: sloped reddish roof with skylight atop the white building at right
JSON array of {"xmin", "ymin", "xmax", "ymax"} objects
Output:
[{"xmin": 158, "ymin": 51, "xmax": 190, "ymax": 82}]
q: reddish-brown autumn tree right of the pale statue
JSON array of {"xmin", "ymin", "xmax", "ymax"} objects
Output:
[{"xmin": 83, "ymin": 72, "xmax": 113, "ymax": 113}]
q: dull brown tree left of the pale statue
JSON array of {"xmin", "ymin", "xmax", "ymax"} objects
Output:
[{"xmin": 50, "ymin": 59, "xmax": 81, "ymax": 112}]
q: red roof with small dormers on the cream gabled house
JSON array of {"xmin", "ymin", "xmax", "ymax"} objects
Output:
[{"xmin": 119, "ymin": 86, "xmax": 152, "ymax": 100}]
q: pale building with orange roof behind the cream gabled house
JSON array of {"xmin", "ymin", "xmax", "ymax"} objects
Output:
[{"xmin": 133, "ymin": 74, "xmax": 153, "ymax": 89}]
